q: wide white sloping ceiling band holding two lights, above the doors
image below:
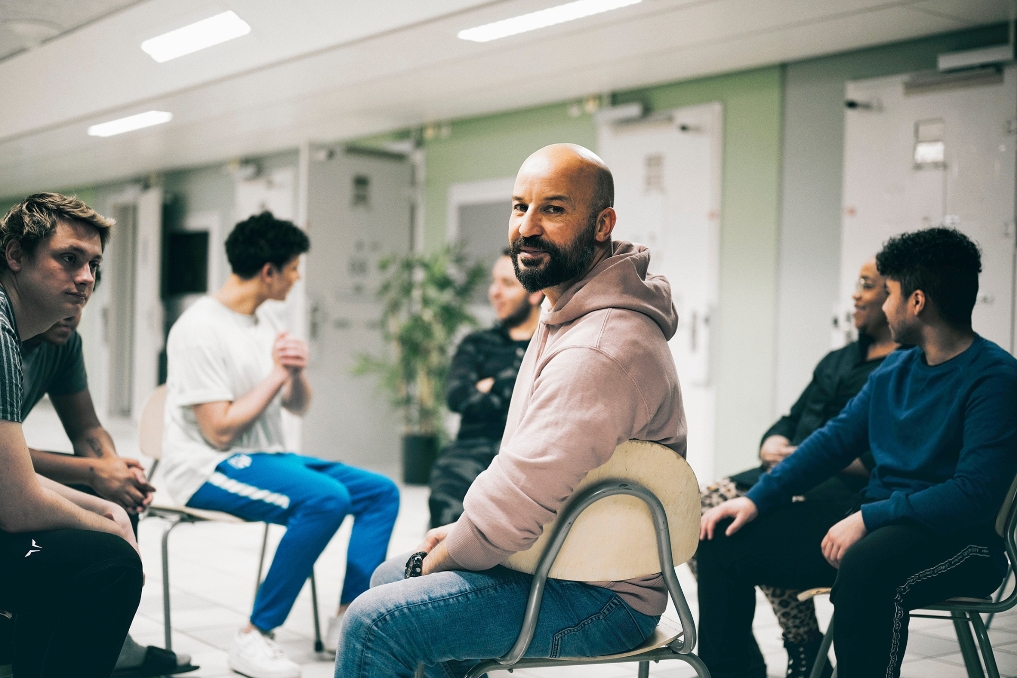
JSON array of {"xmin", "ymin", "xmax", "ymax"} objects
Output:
[{"xmin": 0, "ymin": 0, "xmax": 998, "ymax": 195}]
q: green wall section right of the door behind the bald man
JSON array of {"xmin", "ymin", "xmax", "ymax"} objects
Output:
[{"xmin": 614, "ymin": 67, "xmax": 782, "ymax": 481}]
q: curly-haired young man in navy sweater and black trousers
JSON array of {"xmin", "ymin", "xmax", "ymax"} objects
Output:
[{"xmin": 698, "ymin": 228, "xmax": 1017, "ymax": 678}]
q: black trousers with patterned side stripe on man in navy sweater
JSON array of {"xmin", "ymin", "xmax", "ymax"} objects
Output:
[{"xmin": 697, "ymin": 500, "xmax": 1005, "ymax": 678}]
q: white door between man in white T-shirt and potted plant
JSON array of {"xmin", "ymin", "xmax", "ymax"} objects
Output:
[{"xmin": 303, "ymin": 146, "xmax": 414, "ymax": 473}]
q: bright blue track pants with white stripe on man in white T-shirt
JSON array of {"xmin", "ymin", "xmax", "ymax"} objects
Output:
[{"xmin": 187, "ymin": 452, "xmax": 399, "ymax": 631}]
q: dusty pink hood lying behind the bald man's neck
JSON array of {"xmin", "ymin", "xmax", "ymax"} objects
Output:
[{"xmin": 543, "ymin": 240, "xmax": 678, "ymax": 340}]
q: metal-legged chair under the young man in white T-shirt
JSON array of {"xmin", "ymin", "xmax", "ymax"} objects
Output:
[{"xmin": 137, "ymin": 384, "xmax": 324, "ymax": 653}]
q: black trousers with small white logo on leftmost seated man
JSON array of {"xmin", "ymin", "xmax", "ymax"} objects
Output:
[{"xmin": 0, "ymin": 530, "xmax": 142, "ymax": 678}]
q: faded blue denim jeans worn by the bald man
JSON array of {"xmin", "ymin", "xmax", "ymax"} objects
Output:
[{"xmin": 336, "ymin": 554, "xmax": 659, "ymax": 678}]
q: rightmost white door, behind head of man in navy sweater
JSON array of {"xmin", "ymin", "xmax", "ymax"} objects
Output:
[{"xmin": 835, "ymin": 66, "xmax": 1017, "ymax": 353}]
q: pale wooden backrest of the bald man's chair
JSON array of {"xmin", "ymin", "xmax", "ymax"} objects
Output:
[{"xmin": 502, "ymin": 440, "xmax": 701, "ymax": 581}]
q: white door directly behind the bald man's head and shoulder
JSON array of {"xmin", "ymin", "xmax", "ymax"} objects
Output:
[{"xmin": 599, "ymin": 104, "xmax": 723, "ymax": 482}]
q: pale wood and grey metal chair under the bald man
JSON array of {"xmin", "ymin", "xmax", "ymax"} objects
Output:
[{"xmin": 416, "ymin": 440, "xmax": 710, "ymax": 678}]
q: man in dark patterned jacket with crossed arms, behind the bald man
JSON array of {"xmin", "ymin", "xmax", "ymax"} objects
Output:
[{"xmin": 428, "ymin": 251, "xmax": 543, "ymax": 528}]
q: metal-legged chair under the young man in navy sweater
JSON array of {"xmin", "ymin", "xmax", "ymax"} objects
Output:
[{"xmin": 798, "ymin": 471, "xmax": 1017, "ymax": 678}]
